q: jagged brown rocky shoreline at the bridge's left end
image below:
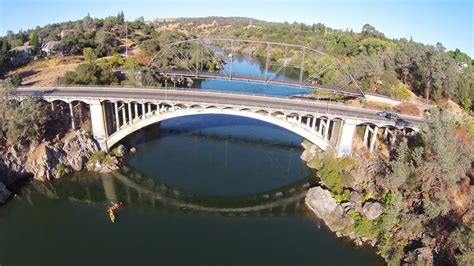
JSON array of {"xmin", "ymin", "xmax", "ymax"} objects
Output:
[{"xmin": 0, "ymin": 130, "xmax": 126, "ymax": 204}]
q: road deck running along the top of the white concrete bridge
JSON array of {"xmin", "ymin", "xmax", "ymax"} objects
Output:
[{"xmin": 18, "ymin": 87, "xmax": 422, "ymax": 127}]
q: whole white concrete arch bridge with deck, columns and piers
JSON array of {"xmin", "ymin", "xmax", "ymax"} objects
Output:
[{"xmin": 18, "ymin": 87, "xmax": 421, "ymax": 156}]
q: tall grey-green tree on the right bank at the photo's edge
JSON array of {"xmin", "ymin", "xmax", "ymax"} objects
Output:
[{"xmin": 417, "ymin": 109, "xmax": 474, "ymax": 219}]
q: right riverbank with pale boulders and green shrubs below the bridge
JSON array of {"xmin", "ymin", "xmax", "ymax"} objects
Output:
[{"xmin": 301, "ymin": 141, "xmax": 433, "ymax": 265}]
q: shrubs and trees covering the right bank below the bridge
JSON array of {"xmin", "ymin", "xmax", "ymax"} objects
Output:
[{"xmin": 308, "ymin": 109, "xmax": 474, "ymax": 265}]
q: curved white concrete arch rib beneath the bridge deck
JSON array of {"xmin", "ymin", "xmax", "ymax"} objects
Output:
[{"xmin": 106, "ymin": 107, "xmax": 329, "ymax": 150}]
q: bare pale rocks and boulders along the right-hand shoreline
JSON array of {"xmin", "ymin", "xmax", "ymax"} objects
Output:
[{"xmin": 301, "ymin": 141, "xmax": 433, "ymax": 265}]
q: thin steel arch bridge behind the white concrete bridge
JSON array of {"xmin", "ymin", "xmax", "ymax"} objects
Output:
[{"xmin": 148, "ymin": 37, "xmax": 364, "ymax": 97}]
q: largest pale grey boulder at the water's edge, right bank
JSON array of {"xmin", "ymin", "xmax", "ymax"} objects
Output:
[{"xmin": 305, "ymin": 187, "xmax": 354, "ymax": 232}]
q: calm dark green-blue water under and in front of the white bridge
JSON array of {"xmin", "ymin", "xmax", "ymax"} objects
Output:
[{"xmin": 0, "ymin": 115, "xmax": 383, "ymax": 266}]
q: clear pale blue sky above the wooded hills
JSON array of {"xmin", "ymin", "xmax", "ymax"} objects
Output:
[{"xmin": 0, "ymin": 0, "xmax": 474, "ymax": 57}]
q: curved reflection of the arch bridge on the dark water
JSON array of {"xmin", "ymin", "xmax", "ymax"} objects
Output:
[{"xmin": 21, "ymin": 163, "xmax": 310, "ymax": 216}]
